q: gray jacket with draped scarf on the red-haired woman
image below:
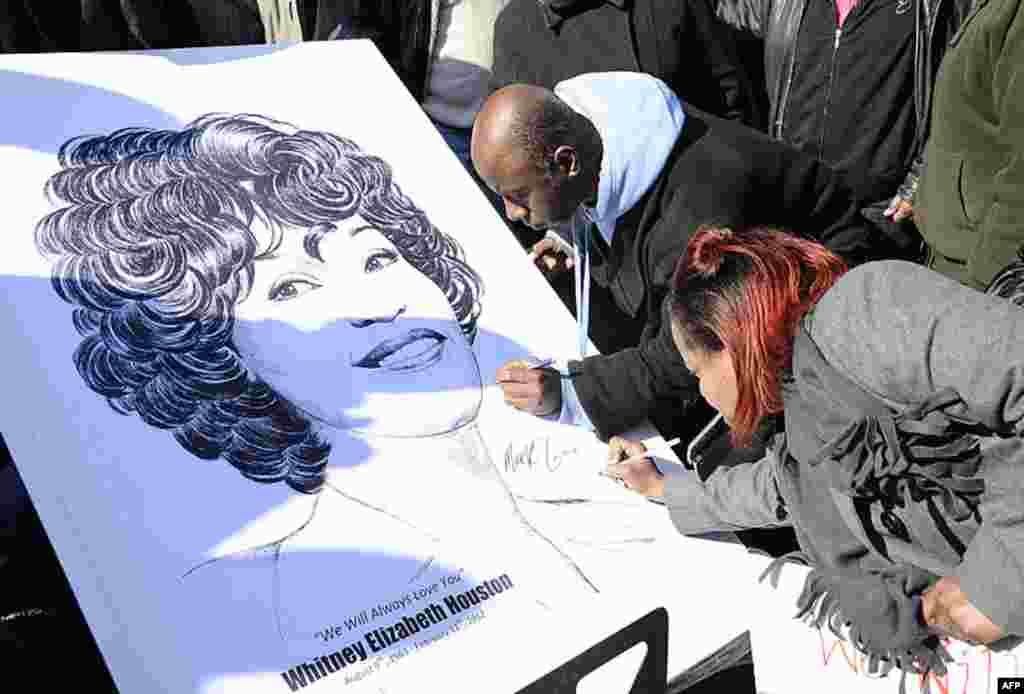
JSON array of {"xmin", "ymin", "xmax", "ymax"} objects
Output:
[{"xmin": 665, "ymin": 261, "xmax": 1024, "ymax": 636}]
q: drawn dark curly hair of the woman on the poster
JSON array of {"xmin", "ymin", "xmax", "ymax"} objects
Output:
[{"xmin": 36, "ymin": 115, "xmax": 481, "ymax": 492}]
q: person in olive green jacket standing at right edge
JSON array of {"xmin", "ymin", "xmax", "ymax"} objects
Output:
[{"xmin": 914, "ymin": 0, "xmax": 1024, "ymax": 289}]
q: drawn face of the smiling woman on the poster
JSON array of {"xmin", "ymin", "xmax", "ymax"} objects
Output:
[{"xmin": 234, "ymin": 215, "xmax": 482, "ymax": 437}]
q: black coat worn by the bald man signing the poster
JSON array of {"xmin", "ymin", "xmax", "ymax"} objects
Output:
[{"xmin": 569, "ymin": 104, "xmax": 895, "ymax": 438}]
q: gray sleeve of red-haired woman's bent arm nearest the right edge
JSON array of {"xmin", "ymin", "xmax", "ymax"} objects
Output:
[{"xmin": 810, "ymin": 261, "xmax": 1024, "ymax": 636}]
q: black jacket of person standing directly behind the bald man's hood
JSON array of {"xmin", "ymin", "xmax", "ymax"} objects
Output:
[{"xmin": 493, "ymin": 0, "xmax": 756, "ymax": 124}]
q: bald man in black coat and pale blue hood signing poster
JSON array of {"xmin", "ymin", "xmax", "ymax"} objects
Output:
[{"xmin": 471, "ymin": 73, "xmax": 894, "ymax": 448}]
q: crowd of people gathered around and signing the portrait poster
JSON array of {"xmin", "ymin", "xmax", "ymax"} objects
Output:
[{"xmin": 0, "ymin": 0, "xmax": 1024, "ymax": 691}]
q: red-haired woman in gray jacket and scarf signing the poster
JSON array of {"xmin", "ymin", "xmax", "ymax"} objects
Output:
[{"xmin": 609, "ymin": 227, "xmax": 1024, "ymax": 674}]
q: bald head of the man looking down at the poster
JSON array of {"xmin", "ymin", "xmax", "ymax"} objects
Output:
[{"xmin": 471, "ymin": 84, "xmax": 602, "ymax": 229}]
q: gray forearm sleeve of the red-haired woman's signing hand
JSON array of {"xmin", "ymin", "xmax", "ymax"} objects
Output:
[{"xmin": 659, "ymin": 458, "xmax": 790, "ymax": 535}]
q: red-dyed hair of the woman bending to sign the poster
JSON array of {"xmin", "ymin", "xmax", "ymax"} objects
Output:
[{"xmin": 671, "ymin": 226, "xmax": 847, "ymax": 444}]
